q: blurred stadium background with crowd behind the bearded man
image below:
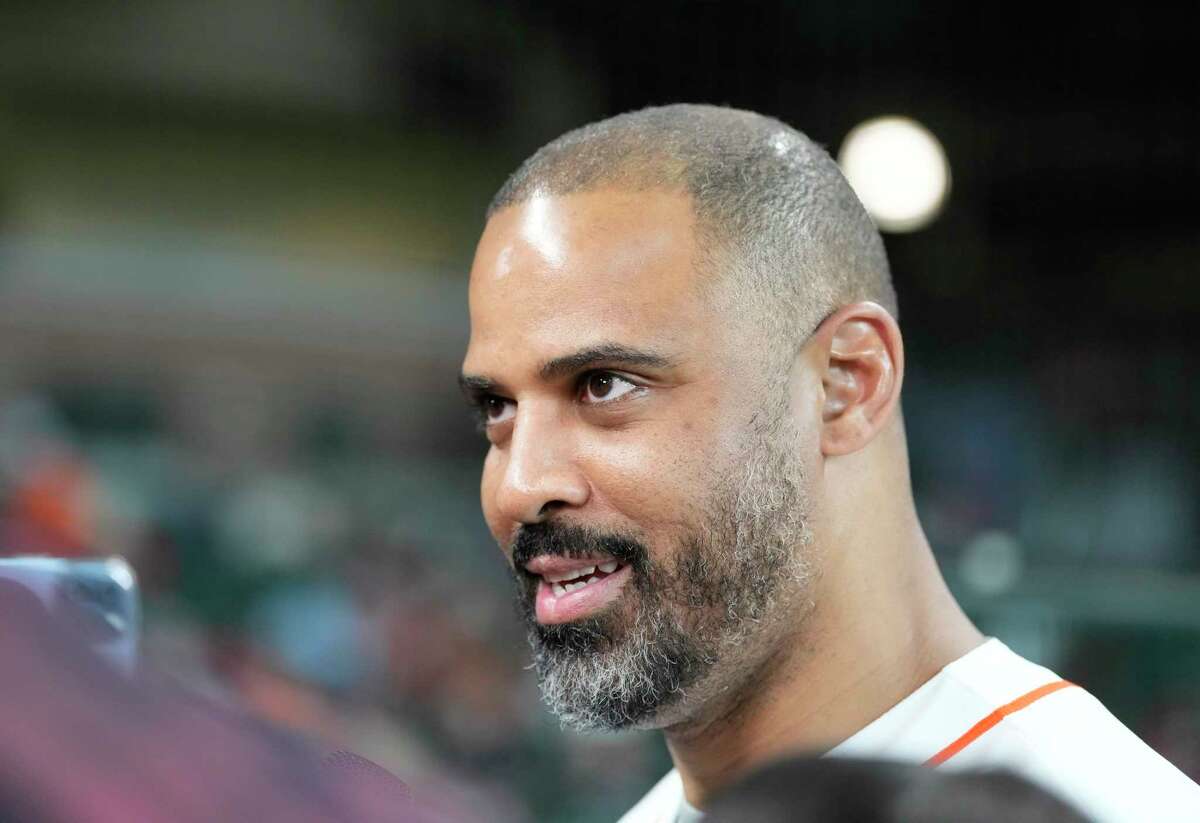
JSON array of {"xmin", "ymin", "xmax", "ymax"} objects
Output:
[{"xmin": 0, "ymin": 0, "xmax": 1200, "ymax": 822}]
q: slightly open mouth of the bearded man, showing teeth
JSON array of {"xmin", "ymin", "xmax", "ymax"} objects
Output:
[{"xmin": 524, "ymin": 555, "xmax": 631, "ymax": 625}]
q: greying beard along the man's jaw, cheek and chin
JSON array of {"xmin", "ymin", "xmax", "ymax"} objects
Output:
[{"xmin": 524, "ymin": 419, "xmax": 811, "ymax": 731}]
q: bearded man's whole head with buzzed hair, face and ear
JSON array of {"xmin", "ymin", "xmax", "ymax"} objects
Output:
[{"xmin": 463, "ymin": 106, "xmax": 902, "ymax": 728}]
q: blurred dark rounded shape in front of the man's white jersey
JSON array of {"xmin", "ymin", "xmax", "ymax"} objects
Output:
[{"xmin": 704, "ymin": 758, "xmax": 1086, "ymax": 823}]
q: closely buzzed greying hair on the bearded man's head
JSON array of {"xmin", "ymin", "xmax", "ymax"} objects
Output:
[{"xmin": 487, "ymin": 103, "xmax": 899, "ymax": 356}]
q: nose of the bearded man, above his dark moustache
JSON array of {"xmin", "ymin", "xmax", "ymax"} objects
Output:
[{"xmin": 494, "ymin": 408, "xmax": 588, "ymax": 524}]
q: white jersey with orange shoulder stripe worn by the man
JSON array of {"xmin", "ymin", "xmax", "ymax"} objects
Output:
[{"xmin": 619, "ymin": 638, "xmax": 1200, "ymax": 823}]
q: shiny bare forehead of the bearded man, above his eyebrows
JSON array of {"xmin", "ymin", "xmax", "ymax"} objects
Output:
[{"xmin": 466, "ymin": 191, "xmax": 712, "ymax": 371}]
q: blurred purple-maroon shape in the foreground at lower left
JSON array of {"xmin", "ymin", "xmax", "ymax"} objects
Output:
[{"xmin": 0, "ymin": 581, "xmax": 446, "ymax": 823}]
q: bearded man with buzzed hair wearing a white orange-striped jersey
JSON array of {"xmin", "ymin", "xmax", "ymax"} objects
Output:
[{"xmin": 461, "ymin": 106, "xmax": 1200, "ymax": 823}]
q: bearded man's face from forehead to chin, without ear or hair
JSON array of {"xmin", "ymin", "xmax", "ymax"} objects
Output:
[{"xmin": 463, "ymin": 191, "xmax": 814, "ymax": 728}]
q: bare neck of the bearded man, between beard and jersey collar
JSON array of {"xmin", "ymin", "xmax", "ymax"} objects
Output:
[{"xmin": 666, "ymin": 518, "xmax": 983, "ymax": 807}]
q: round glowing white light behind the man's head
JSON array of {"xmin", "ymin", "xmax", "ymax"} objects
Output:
[{"xmin": 838, "ymin": 116, "xmax": 950, "ymax": 233}]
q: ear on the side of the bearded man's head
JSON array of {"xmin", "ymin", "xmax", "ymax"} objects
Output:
[{"xmin": 812, "ymin": 302, "xmax": 904, "ymax": 457}]
